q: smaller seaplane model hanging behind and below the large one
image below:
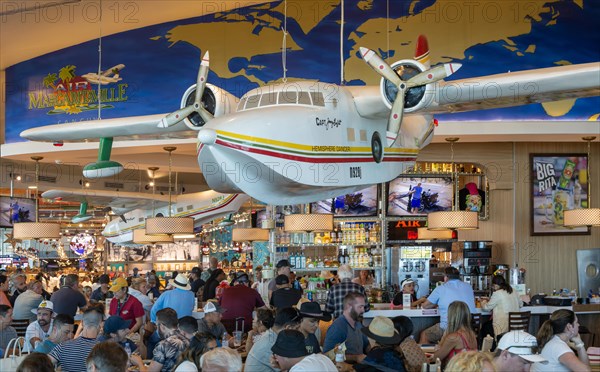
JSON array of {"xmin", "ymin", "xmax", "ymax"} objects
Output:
[{"xmin": 42, "ymin": 189, "xmax": 250, "ymax": 244}]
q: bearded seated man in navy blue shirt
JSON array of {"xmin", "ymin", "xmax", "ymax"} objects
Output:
[{"xmin": 323, "ymin": 292, "xmax": 370, "ymax": 363}]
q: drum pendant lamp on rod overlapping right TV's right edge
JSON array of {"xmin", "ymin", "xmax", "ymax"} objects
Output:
[{"xmin": 427, "ymin": 137, "xmax": 479, "ymax": 231}]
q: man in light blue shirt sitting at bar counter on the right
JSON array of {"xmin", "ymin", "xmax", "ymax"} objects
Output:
[{"xmin": 419, "ymin": 266, "xmax": 475, "ymax": 344}]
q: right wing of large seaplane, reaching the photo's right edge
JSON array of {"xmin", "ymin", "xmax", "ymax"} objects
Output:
[{"xmin": 418, "ymin": 62, "xmax": 600, "ymax": 114}]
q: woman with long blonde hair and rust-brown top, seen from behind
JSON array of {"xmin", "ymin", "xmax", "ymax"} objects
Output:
[{"xmin": 432, "ymin": 301, "xmax": 477, "ymax": 364}]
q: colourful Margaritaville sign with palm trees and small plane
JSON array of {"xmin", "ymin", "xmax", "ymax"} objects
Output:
[{"xmin": 28, "ymin": 65, "xmax": 128, "ymax": 115}]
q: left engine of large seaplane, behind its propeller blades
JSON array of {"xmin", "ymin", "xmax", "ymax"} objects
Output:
[{"xmin": 181, "ymin": 83, "xmax": 238, "ymax": 130}]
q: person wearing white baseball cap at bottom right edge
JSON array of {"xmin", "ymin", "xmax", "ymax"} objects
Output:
[{"xmin": 492, "ymin": 331, "xmax": 548, "ymax": 372}]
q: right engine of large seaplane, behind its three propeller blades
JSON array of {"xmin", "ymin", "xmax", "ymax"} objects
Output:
[{"xmin": 380, "ymin": 59, "xmax": 434, "ymax": 113}]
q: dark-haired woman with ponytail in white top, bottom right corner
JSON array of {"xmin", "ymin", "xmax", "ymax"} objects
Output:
[{"xmin": 531, "ymin": 309, "xmax": 591, "ymax": 371}]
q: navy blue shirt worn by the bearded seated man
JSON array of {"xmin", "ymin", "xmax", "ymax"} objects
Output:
[{"xmin": 323, "ymin": 315, "xmax": 369, "ymax": 355}]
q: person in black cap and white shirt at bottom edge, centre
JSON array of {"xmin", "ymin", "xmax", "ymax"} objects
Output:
[{"xmin": 271, "ymin": 329, "xmax": 338, "ymax": 372}]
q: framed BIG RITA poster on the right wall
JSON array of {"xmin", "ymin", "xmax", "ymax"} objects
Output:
[{"xmin": 530, "ymin": 154, "xmax": 590, "ymax": 235}]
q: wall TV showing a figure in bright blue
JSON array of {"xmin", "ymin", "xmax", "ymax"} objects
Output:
[{"xmin": 387, "ymin": 175, "xmax": 453, "ymax": 217}]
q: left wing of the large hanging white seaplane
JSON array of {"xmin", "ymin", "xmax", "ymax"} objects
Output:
[{"xmin": 21, "ymin": 114, "xmax": 196, "ymax": 142}]
